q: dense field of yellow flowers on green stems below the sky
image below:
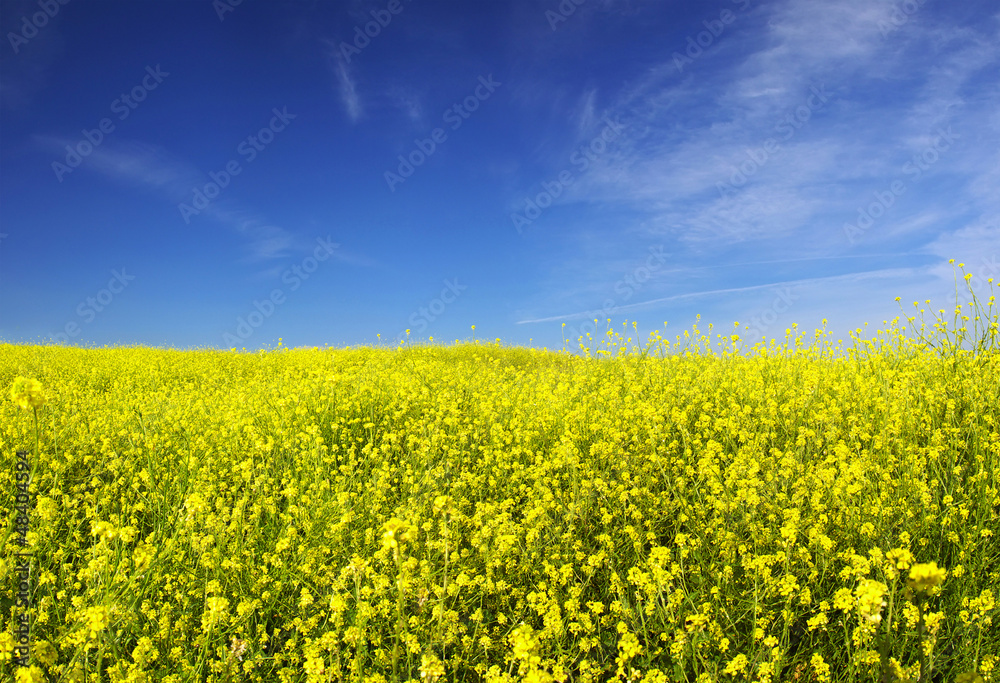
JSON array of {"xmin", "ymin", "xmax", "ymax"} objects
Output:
[{"xmin": 0, "ymin": 276, "xmax": 1000, "ymax": 683}]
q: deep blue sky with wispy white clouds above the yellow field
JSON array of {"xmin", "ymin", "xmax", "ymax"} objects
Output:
[{"xmin": 0, "ymin": 0, "xmax": 1000, "ymax": 349}]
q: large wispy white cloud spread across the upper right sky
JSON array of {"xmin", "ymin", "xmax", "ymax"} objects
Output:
[{"xmin": 523, "ymin": 0, "xmax": 1000, "ymax": 322}]
